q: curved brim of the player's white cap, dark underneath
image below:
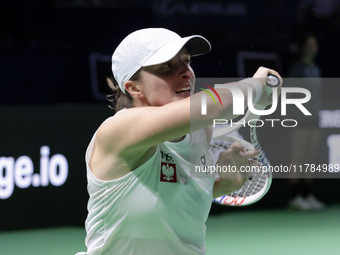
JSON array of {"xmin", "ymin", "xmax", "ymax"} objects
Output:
[{"xmin": 142, "ymin": 35, "xmax": 211, "ymax": 66}]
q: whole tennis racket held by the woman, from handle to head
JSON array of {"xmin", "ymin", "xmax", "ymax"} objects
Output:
[{"xmin": 209, "ymin": 74, "xmax": 280, "ymax": 206}]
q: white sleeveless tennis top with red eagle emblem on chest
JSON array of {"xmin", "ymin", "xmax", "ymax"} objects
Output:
[{"xmin": 77, "ymin": 116, "xmax": 215, "ymax": 255}]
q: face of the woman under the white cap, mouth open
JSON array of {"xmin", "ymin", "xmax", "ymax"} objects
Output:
[{"xmin": 128, "ymin": 48, "xmax": 195, "ymax": 106}]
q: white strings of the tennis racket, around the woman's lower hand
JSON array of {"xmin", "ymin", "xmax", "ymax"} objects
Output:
[{"xmin": 209, "ymin": 140, "xmax": 268, "ymax": 197}]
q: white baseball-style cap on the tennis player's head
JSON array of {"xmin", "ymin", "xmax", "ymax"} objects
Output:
[{"xmin": 112, "ymin": 28, "xmax": 211, "ymax": 93}]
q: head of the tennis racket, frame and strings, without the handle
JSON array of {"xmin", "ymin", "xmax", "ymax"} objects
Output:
[{"xmin": 209, "ymin": 135, "xmax": 272, "ymax": 206}]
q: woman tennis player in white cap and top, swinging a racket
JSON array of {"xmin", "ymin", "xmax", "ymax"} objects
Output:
[{"xmin": 78, "ymin": 28, "xmax": 279, "ymax": 255}]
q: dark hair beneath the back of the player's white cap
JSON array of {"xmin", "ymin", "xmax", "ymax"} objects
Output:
[{"xmin": 106, "ymin": 69, "xmax": 140, "ymax": 112}]
